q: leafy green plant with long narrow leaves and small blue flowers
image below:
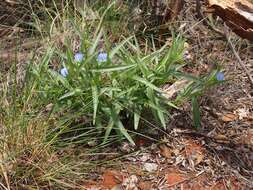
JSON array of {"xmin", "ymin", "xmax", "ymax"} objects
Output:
[{"xmin": 30, "ymin": 27, "xmax": 222, "ymax": 144}]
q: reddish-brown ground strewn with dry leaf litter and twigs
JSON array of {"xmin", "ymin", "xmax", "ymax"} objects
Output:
[{"xmin": 0, "ymin": 0, "xmax": 253, "ymax": 190}]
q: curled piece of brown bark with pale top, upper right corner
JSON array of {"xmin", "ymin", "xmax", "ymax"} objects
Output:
[{"xmin": 208, "ymin": 0, "xmax": 253, "ymax": 41}]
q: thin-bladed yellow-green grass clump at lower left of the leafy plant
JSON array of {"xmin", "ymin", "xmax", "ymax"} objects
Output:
[{"xmin": 0, "ymin": 77, "xmax": 87, "ymax": 189}]
